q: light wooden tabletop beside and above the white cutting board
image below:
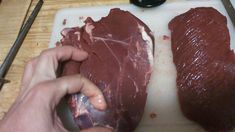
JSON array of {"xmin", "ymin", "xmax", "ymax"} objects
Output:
[{"xmin": 0, "ymin": 0, "xmax": 129, "ymax": 119}]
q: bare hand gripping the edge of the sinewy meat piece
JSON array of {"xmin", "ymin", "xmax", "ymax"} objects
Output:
[{"xmin": 0, "ymin": 46, "xmax": 111, "ymax": 132}]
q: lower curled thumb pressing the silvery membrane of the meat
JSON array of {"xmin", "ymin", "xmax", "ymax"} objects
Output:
[{"xmin": 37, "ymin": 75, "xmax": 107, "ymax": 110}]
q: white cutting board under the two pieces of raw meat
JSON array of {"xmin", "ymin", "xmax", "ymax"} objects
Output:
[{"xmin": 49, "ymin": 0, "xmax": 235, "ymax": 132}]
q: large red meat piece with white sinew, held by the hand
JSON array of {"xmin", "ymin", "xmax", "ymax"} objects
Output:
[{"xmin": 61, "ymin": 9, "xmax": 154, "ymax": 132}]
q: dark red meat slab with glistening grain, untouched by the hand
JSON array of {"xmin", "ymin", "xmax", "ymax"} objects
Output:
[{"xmin": 169, "ymin": 7, "xmax": 235, "ymax": 132}]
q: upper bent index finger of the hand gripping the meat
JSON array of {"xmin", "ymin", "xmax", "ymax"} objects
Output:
[{"xmin": 31, "ymin": 46, "xmax": 88, "ymax": 84}]
